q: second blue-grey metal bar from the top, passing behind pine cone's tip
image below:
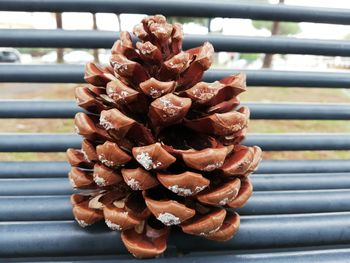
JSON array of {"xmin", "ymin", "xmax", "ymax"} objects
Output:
[{"xmin": 0, "ymin": 29, "xmax": 350, "ymax": 56}]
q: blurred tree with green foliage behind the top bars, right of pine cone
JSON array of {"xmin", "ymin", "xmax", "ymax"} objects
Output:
[{"xmin": 253, "ymin": 0, "xmax": 300, "ymax": 68}]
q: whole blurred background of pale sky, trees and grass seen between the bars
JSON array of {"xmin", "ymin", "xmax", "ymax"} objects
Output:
[{"xmin": 0, "ymin": 0, "xmax": 350, "ymax": 161}]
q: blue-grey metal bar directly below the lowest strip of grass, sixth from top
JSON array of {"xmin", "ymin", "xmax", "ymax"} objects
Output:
[{"xmin": 0, "ymin": 160, "xmax": 350, "ymax": 179}]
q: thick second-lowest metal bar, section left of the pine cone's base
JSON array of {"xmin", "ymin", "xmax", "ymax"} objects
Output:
[{"xmin": 0, "ymin": 221, "xmax": 127, "ymax": 257}]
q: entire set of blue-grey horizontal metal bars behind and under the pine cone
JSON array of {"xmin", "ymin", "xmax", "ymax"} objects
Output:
[{"xmin": 0, "ymin": 0, "xmax": 350, "ymax": 262}]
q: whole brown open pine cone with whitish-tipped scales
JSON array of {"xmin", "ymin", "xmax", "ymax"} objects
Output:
[{"xmin": 67, "ymin": 15, "xmax": 261, "ymax": 258}]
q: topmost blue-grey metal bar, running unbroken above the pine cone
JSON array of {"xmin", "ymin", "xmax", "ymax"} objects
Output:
[{"xmin": 0, "ymin": 0, "xmax": 350, "ymax": 25}]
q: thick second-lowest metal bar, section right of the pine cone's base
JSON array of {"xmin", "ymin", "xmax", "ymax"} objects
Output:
[{"xmin": 170, "ymin": 212, "xmax": 350, "ymax": 252}]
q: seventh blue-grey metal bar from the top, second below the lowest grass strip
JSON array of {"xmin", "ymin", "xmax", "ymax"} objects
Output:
[{"xmin": 0, "ymin": 173, "xmax": 350, "ymax": 196}]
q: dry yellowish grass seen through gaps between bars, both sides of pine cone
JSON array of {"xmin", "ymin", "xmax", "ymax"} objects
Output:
[{"xmin": 0, "ymin": 83, "xmax": 350, "ymax": 161}]
